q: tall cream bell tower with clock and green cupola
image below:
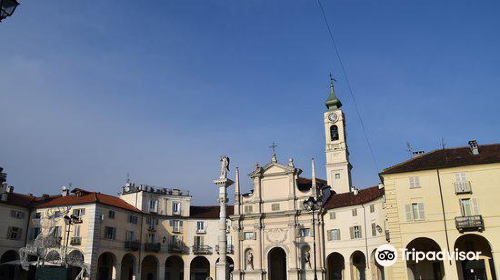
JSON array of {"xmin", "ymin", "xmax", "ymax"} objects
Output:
[{"xmin": 323, "ymin": 74, "xmax": 352, "ymax": 193}]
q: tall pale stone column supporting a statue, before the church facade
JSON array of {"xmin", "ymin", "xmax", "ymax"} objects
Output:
[{"xmin": 213, "ymin": 176, "xmax": 234, "ymax": 280}]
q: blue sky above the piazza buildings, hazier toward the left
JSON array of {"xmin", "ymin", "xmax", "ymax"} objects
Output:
[{"xmin": 0, "ymin": 0, "xmax": 500, "ymax": 204}]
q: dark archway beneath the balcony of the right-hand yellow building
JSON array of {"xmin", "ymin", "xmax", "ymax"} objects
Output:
[{"xmin": 455, "ymin": 234, "xmax": 496, "ymax": 280}]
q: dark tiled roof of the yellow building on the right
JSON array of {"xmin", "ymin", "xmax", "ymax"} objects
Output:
[{"xmin": 380, "ymin": 144, "xmax": 500, "ymax": 175}]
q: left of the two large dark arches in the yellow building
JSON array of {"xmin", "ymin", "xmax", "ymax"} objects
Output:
[{"xmin": 406, "ymin": 237, "xmax": 444, "ymax": 280}]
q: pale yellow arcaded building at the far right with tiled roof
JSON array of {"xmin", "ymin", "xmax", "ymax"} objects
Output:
[{"xmin": 380, "ymin": 141, "xmax": 500, "ymax": 280}]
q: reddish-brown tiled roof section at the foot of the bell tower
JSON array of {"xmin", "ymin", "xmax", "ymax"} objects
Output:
[{"xmin": 324, "ymin": 186, "xmax": 384, "ymax": 209}]
